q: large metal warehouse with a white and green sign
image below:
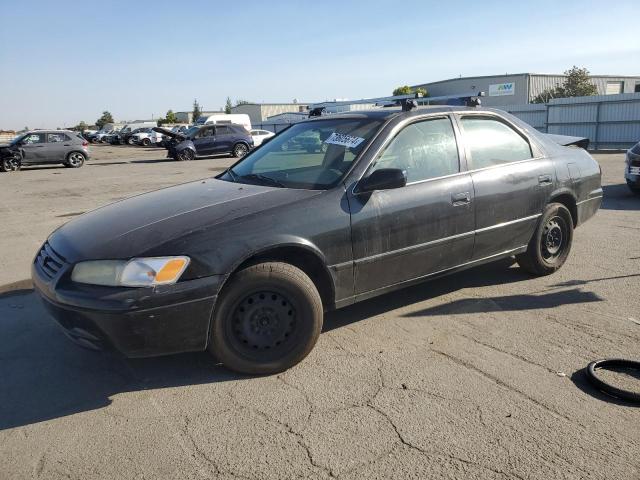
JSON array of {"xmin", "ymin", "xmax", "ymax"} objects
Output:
[{"xmin": 412, "ymin": 73, "xmax": 640, "ymax": 107}]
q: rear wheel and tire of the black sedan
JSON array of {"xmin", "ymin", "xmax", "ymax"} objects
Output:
[{"xmin": 516, "ymin": 203, "xmax": 573, "ymax": 276}]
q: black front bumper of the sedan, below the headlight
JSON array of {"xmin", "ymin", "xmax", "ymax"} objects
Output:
[{"xmin": 31, "ymin": 249, "xmax": 222, "ymax": 357}]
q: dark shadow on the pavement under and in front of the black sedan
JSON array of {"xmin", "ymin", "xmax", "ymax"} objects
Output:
[{"xmin": 0, "ymin": 259, "xmax": 600, "ymax": 430}]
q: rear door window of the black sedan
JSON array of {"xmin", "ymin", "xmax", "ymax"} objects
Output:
[{"xmin": 461, "ymin": 116, "xmax": 533, "ymax": 169}]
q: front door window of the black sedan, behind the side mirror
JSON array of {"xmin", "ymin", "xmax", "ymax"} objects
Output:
[{"xmin": 372, "ymin": 118, "xmax": 460, "ymax": 183}]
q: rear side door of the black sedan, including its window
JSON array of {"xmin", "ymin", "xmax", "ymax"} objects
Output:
[{"xmin": 458, "ymin": 112, "xmax": 555, "ymax": 260}]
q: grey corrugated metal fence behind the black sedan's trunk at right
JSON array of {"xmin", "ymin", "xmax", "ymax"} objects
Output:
[{"xmin": 501, "ymin": 93, "xmax": 640, "ymax": 150}]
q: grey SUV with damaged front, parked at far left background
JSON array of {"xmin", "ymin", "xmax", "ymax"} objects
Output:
[{"xmin": 0, "ymin": 130, "xmax": 89, "ymax": 172}]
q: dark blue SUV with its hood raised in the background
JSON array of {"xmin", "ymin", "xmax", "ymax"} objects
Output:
[{"xmin": 153, "ymin": 124, "xmax": 254, "ymax": 160}]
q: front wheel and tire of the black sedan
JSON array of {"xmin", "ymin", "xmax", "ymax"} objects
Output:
[{"xmin": 208, "ymin": 262, "xmax": 323, "ymax": 375}]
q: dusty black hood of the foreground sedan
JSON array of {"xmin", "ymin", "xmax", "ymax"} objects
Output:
[{"xmin": 49, "ymin": 179, "xmax": 321, "ymax": 263}]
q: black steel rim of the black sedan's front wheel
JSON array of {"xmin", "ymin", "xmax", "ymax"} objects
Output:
[{"xmin": 228, "ymin": 290, "xmax": 297, "ymax": 355}]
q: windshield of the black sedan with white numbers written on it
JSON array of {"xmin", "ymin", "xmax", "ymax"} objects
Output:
[{"xmin": 220, "ymin": 118, "xmax": 383, "ymax": 190}]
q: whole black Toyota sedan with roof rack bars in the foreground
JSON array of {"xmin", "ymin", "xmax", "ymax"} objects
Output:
[{"xmin": 32, "ymin": 107, "xmax": 602, "ymax": 374}]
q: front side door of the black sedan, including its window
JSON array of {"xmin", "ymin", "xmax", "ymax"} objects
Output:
[{"xmin": 348, "ymin": 116, "xmax": 474, "ymax": 295}]
